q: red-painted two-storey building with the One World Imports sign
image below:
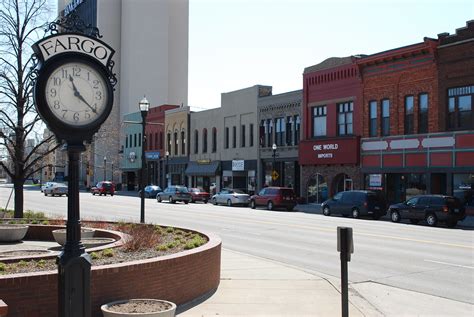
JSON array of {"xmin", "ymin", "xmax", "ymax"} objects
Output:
[{"xmin": 299, "ymin": 56, "xmax": 362, "ymax": 203}]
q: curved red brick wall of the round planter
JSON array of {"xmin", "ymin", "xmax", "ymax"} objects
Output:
[{"xmin": 0, "ymin": 228, "xmax": 221, "ymax": 317}]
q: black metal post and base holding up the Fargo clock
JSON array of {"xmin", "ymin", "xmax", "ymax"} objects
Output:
[{"xmin": 56, "ymin": 145, "xmax": 91, "ymax": 317}]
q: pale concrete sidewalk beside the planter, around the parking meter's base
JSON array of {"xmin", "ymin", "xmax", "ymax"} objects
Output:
[{"xmin": 177, "ymin": 249, "xmax": 474, "ymax": 317}]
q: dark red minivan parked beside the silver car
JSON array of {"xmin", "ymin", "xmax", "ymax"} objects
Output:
[{"xmin": 250, "ymin": 187, "xmax": 297, "ymax": 211}]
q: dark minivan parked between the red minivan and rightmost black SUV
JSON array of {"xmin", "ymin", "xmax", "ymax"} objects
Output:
[{"xmin": 321, "ymin": 190, "xmax": 387, "ymax": 219}]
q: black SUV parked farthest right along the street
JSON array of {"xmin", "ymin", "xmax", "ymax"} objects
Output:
[{"xmin": 389, "ymin": 195, "xmax": 466, "ymax": 227}]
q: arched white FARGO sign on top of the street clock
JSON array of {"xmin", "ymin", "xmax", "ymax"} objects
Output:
[{"xmin": 33, "ymin": 33, "xmax": 114, "ymax": 67}]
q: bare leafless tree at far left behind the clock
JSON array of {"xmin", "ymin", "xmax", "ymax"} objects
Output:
[{"xmin": 0, "ymin": 0, "xmax": 59, "ymax": 218}]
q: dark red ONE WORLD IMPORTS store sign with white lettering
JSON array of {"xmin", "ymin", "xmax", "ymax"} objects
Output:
[{"xmin": 299, "ymin": 137, "xmax": 359, "ymax": 165}]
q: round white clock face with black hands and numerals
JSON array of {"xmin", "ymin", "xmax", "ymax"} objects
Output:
[{"xmin": 44, "ymin": 61, "xmax": 110, "ymax": 127}]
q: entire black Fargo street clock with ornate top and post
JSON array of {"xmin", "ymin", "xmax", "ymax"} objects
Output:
[{"xmin": 33, "ymin": 13, "xmax": 117, "ymax": 317}]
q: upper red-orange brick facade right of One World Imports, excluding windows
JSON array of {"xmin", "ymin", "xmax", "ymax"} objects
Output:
[{"xmin": 357, "ymin": 39, "xmax": 440, "ymax": 137}]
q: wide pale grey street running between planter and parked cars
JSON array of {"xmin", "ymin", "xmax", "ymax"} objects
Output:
[{"xmin": 0, "ymin": 188, "xmax": 474, "ymax": 304}]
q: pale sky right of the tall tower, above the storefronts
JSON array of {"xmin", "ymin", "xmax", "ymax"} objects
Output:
[{"xmin": 188, "ymin": 0, "xmax": 474, "ymax": 111}]
